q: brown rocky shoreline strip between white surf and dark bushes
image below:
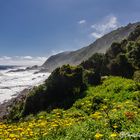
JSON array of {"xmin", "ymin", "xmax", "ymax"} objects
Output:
[{"xmin": 0, "ymin": 88, "xmax": 32, "ymax": 121}]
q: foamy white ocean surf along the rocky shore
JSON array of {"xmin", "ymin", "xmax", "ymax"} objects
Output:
[{"xmin": 0, "ymin": 65, "xmax": 50, "ymax": 103}]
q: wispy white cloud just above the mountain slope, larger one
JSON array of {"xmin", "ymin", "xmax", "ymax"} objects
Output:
[{"xmin": 91, "ymin": 16, "xmax": 119, "ymax": 39}]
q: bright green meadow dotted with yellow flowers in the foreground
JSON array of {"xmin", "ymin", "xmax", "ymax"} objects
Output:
[{"xmin": 0, "ymin": 77, "xmax": 140, "ymax": 140}]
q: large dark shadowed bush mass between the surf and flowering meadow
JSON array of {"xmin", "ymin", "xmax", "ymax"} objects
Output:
[{"xmin": 8, "ymin": 65, "xmax": 101, "ymax": 120}]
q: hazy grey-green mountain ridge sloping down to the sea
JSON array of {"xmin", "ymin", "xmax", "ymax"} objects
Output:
[{"xmin": 42, "ymin": 22, "xmax": 140, "ymax": 71}]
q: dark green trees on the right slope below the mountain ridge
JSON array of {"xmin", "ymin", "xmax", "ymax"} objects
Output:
[{"xmin": 81, "ymin": 26, "xmax": 140, "ymax": 79}]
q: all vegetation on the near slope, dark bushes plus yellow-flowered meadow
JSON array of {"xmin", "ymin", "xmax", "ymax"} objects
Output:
[{"xmin": 0, "ymin": 26, "xmax": 140, "ymax": 140}]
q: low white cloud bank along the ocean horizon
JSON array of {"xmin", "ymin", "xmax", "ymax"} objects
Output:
[{"xmin": 0, "ymin": 56, "xmax": 47, "ymax": 66}]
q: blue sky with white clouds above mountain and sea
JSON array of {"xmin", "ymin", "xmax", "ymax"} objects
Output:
[{"xmin": 0, "ymin": 0, "xmax": 140, "ymax": 65}]
